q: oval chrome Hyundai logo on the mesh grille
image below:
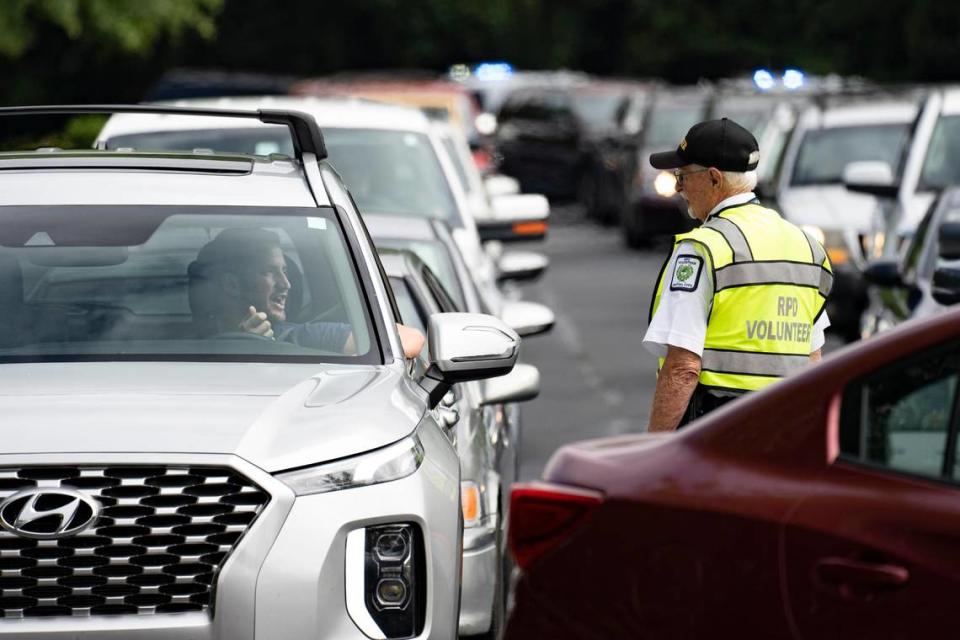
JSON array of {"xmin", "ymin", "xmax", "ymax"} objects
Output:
[{"xmin": 0, "ymin": 488, "xmax": 100, "ymax": 540}]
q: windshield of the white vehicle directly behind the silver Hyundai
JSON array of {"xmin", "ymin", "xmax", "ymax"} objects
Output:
[{"xmin": 107, "ymin": 126, "xmax": 461, "ymax": 226}]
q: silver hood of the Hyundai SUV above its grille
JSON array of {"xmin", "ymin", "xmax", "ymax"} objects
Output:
[{"xmin": 0, "ymin": 362, "xmax": 424, "ymax": 472}]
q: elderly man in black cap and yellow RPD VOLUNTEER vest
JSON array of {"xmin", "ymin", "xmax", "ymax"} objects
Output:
[{"xmin": 643, "ymin": 118, "xmax": 833, "ymax": 431}]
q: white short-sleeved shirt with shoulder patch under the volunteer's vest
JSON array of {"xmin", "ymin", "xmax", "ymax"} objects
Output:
[{"xmin": 643, "ymin": 193, "xmax": 830, "ymax": 358}]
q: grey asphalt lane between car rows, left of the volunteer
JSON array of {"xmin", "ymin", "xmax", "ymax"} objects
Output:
[{"xmin": 520, "ymin": 208, "xmax": 840, "ymax": 480}]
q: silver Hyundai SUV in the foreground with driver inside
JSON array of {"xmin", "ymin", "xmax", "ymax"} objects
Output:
[{"xmin": 0, "ymin": 107, "xmax": 519, "ymax": 640}]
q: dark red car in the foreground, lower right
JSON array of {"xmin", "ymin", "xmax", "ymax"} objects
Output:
[{"xmin": 506, "ymin": 310, "xmax": 960, "ymax": 640}]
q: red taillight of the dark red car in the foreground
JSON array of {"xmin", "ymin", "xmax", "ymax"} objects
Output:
[{"xmin": 509, "ymin": 484, "xmax": 603, "ymax": 569}]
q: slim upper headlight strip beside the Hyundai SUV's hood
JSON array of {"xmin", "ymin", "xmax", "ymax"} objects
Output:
[{"xmin": 277, "ymin": 435, "xmax": 424, "ymax": 496}]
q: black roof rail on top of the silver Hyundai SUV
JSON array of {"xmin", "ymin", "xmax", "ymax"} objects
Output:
[{"xmin": 0, "ymin": 104, "xmax": 327, "ymax": 162}]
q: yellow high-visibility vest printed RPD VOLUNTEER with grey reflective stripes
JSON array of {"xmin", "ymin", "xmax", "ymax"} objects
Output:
[{"xmin": 650, "ymin": 201, "xmax": 833, "ymax": 391}]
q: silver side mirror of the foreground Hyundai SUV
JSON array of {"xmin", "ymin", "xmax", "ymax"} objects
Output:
[{"xmin": 420, "ymin": 313, "xmax": 520, "ymax": 409}]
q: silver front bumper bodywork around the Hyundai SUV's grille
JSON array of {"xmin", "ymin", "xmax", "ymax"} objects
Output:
[{"xmin": 0, "ymin": 429, "xmax": 461, "ymax": 640}]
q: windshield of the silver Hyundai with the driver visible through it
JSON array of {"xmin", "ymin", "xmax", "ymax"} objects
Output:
[{"xmin": 0, "ymin": 206, "xmax": 380, "ymax": 363}]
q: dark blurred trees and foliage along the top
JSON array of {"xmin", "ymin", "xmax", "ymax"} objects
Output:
[{"xmin": 0, "ymin": 0, "xmax": 960, "ymax": 109}]
